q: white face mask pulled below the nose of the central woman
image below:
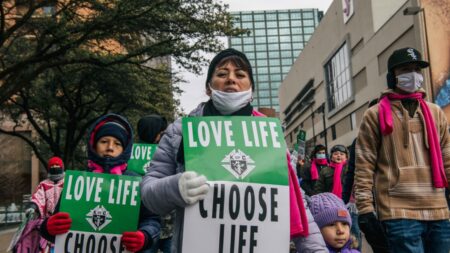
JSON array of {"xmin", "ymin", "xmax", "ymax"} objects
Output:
[{"xmin": 209, "ymin": 86, "xmax": 252, "ymax": 115}]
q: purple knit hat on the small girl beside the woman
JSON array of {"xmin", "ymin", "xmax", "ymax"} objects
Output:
[{"xmin": 309, "ymin": 192, "xmax": 352, "ymax": 228}]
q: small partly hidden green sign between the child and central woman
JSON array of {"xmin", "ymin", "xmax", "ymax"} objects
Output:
[{"xmin": 127, "ymin": 143, "xmax": 158, "ymax": 176}]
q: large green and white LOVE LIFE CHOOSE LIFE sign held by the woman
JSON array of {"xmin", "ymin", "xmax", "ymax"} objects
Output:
[{"xmin": 182, "ymin": 116, "xmax": 290, "ymax": 253}]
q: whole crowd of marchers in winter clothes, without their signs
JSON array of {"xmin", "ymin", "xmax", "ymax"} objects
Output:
[{"xmin": 7, "ymin": 48, "xmax": 450, "ymax": 253}]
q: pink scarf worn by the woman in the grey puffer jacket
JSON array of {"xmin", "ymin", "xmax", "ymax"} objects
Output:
[{"xmin": 252, "ymin": 110, "xmax": 309, "ymax": 238}]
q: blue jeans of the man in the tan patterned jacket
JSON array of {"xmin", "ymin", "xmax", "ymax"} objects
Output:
[{"xmin": 383, "ymin": 219, "xmax": 450, "ymax": 253}]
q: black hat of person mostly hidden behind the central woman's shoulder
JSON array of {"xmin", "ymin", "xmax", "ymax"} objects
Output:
[{"xmin": 137, "ymin": 115, "xmax": 167, "ymax": 144}]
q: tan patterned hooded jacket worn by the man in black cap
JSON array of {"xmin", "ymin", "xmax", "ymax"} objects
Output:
[{"xmin": 355, "ymin": 90, "xmax": 450, "ymax": 220}]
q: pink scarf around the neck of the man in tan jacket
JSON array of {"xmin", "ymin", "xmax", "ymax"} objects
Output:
[{"xmin": 378, "ymin": 92, "xmax": 448, "ymax": 188}]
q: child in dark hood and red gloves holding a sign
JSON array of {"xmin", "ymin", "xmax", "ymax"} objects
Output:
[{"xmin": 41, "ymin": 114, "xmax": 160, "ymax": 252}]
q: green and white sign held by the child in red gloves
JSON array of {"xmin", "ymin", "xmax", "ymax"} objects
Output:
[{"xmin": 55, "ymin": 170, "xmax": 141, "ymax": 252}]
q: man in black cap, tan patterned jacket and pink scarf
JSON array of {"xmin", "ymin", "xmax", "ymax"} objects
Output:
[{"xmin": 355, "ymin": 48, "xmax": 450, "ymax": 253}]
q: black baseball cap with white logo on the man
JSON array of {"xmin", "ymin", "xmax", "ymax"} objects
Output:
[{"xmin": 388, "ymin": 47, "xmax": 430, "ymax": 72}]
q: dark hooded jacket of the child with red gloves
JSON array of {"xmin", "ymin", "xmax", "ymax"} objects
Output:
[{"xmin": 41, "ymin": 113, "xmax": 161, "ymax": 252}]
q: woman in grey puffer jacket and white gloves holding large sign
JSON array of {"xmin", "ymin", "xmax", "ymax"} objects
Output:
[{"xmin": 141, "ymin": 49, "xmax": 327, "ymax": 253}]
